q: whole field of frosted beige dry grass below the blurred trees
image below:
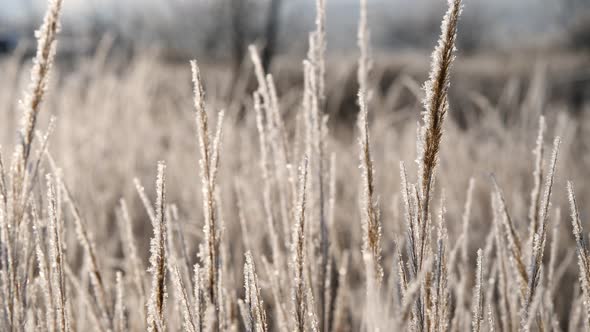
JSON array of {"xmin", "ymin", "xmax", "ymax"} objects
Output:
[{"xmin": 0, "ymin": 0, "xmax": 590, "ymax": 332}]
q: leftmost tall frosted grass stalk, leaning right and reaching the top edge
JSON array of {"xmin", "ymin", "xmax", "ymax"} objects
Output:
[{"xmin": 0, "ymin": 0, "xmax": 67, "ymax": 330}]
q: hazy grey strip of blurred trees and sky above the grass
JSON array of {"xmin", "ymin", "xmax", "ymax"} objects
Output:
[{"xmin": 0, "ymin": 0, "xmax": 590, "ymax": 61}]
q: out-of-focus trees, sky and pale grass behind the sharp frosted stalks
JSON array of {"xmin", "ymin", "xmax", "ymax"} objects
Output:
[{"xmin": 0, "ymin": 0, "xmax": 590, "ymax": 246}]
